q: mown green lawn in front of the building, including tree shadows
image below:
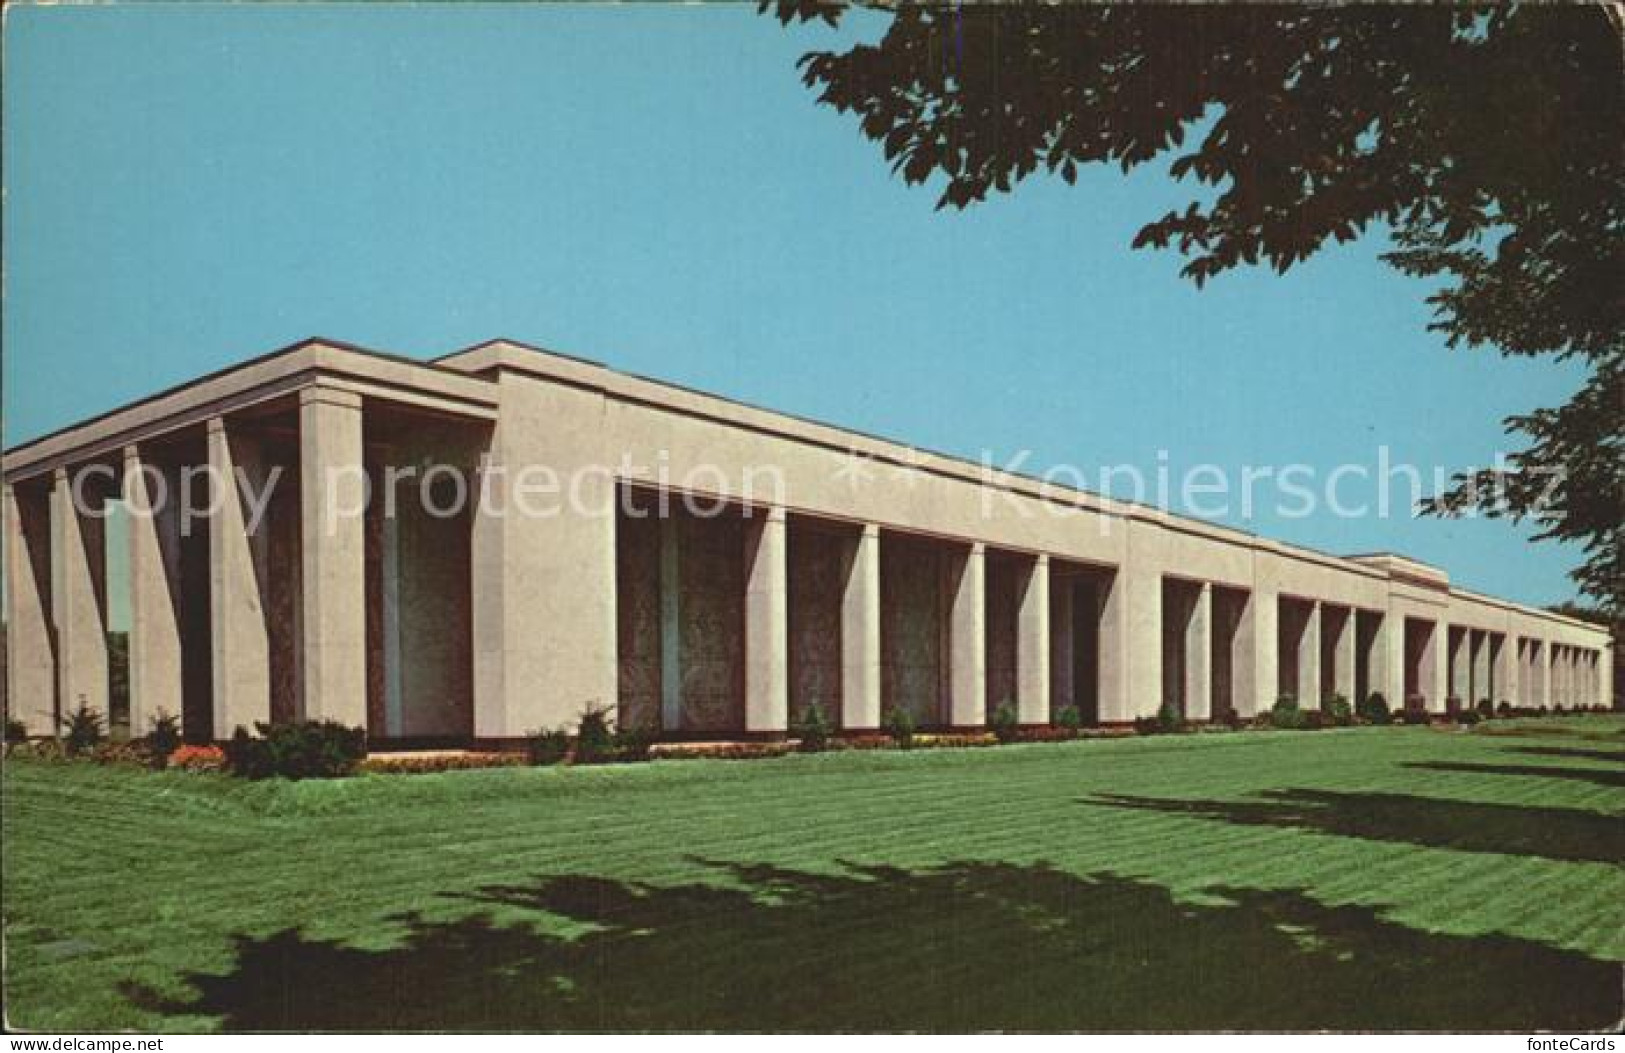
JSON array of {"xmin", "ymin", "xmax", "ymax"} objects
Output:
[{"xmin": 3, "ymin": 717, "xmax": 1625, "ymax": 1030}]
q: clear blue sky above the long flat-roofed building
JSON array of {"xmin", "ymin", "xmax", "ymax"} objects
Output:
[{"xmin": 3, "ymin": 3, "xmax": 1580, "ymax": 617}]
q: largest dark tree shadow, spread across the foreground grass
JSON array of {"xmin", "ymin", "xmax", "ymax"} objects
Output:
[{"xmin": 127, "ymin": 863, "xmax": 1620, "ymax": 1032}]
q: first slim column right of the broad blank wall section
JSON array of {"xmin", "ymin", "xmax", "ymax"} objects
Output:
[{"xmin": 744, "ymin": 507, "xmax": 790, "ymax": 735}]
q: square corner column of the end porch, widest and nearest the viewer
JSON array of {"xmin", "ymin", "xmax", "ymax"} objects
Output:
[{"xmin": 299, "ymin": 387, "xmax": 367, "ymax": 728}]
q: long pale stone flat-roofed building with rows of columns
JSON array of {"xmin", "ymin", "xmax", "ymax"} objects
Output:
[{"xmin": 3, "ymin": 340, "xmax": 1612, "ymax": 744}]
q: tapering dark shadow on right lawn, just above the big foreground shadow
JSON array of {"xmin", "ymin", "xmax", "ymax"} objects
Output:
[{"xmin": 1082, "ymin": 789, "xmax": 1625, "ymax": 863}]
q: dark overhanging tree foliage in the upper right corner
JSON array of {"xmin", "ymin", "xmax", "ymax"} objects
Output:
[{"xmin": 762, "ymin": 0, "xmax": 1625, "ymax": 608}]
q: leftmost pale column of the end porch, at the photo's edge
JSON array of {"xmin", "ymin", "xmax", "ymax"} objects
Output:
[{"xmin": 3, "ymin": 486, "xmax": 57, "ymax": 735}]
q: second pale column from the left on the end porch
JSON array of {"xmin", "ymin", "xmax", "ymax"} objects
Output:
[{"xmin": 50, "ymin": 468, "xmax": 109, "ymax": 720}]
